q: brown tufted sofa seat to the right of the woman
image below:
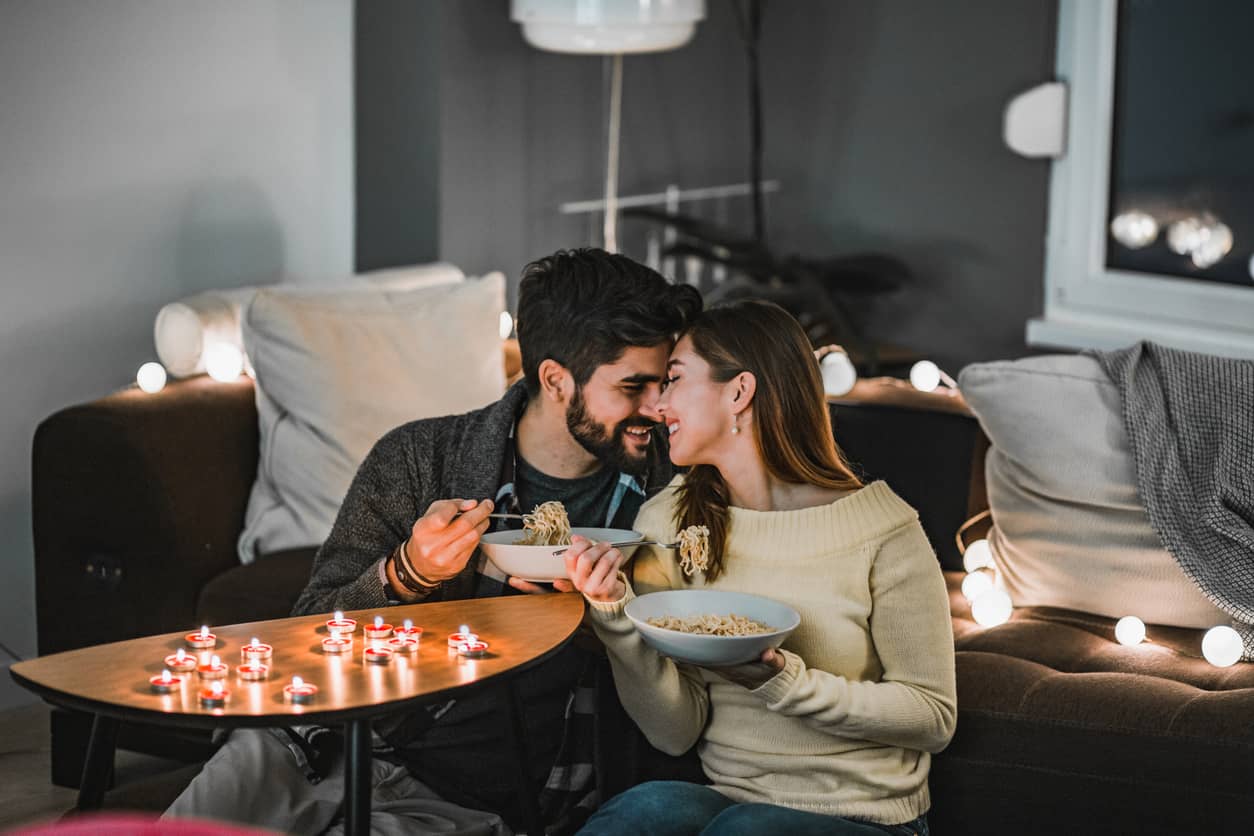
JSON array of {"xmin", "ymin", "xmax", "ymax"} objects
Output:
[{"xmin": 930, "ymin": 572, "xmax": 1254, "ymax": 835}]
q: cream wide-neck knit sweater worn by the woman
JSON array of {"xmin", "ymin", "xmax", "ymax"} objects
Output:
[{"xmin": 589, "ymin": 476, "xmax": 957, "ymax": 825}]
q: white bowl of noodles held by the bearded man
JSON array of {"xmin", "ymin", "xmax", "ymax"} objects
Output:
[{"xmin": 479, "ymin": 503, "xmax": 645, "ymax": 583}]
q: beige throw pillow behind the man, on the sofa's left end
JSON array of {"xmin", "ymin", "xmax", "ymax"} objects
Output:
[{"xmin": 240, "ymin": 273, "xmax": 505, "ymax": 563}]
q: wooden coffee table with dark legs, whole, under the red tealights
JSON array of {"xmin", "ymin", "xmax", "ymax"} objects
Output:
[{"xmin": 10, "ymin": 593, "xmax": 584, "ymax": 835}]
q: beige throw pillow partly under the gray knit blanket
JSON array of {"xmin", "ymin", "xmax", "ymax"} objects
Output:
[{"xmin": 958, "ymin": 355, "xmax": 1229, "ymax": 627}]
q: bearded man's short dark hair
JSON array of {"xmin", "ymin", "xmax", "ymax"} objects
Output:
[{"xmin": 518, "ymin": 248, "xmax": 701, "ymax": 396}]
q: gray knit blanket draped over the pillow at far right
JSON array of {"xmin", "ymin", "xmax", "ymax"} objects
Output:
[{"xmin": 1095, "ymin": 342, "xmax": 1254, "ymax": 661}]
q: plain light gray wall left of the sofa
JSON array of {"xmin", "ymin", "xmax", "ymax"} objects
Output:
[{"xmin": 0, "ymin": 0, "xmax": 352, "ymax": 707}]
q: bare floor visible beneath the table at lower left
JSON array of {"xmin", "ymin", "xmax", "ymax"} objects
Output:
[{"xmin": 0, "ymin": 703, "xmax": 181, "ymax": 832}]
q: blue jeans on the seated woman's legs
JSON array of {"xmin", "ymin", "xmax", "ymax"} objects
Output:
[{"xmin": 579, "ymin": 781, "xmax": 928, "ymax": 836}]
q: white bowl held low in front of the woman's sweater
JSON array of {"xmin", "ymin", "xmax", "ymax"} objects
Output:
[{"xmin": 626, "ymin": 589, "xmax": 801, "ymax": 667}]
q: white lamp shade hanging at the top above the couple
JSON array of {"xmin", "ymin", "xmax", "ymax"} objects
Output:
[{"xmin": 510, "ymin": 0, "xmax": 705, "ymax": 55}]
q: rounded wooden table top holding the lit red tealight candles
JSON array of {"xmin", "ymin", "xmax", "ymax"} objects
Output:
[{"xmin": 10, "ymin": 593, "xmax": 584, "ymax": 726}]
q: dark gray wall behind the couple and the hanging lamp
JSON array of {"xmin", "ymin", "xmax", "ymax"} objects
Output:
[{"xmin": 359, "ymin": 0, "xmax": 1056, "ymax": 370}]
